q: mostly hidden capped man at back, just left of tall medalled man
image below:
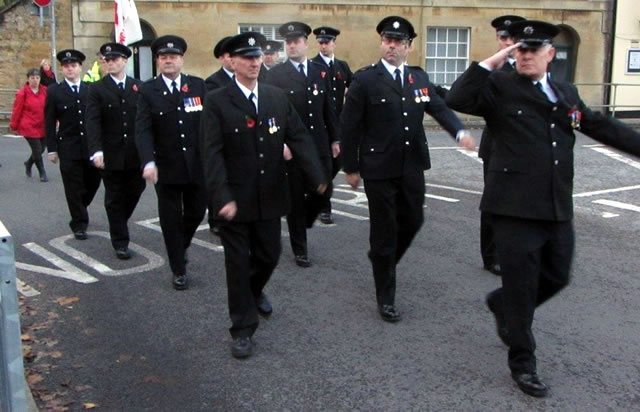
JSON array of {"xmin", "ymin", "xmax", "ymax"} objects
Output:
[{"xmin": 312, "ymin": 26, "xmax": 353, "ymax": 225}]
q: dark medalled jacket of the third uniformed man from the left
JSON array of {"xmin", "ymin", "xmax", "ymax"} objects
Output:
[{"xmin": 136, "ymin": 73, "xmax": 206, "ymax": 184}]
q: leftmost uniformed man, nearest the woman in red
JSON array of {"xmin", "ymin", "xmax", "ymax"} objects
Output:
[{"xmin": 44, "ymin": 49, "xmax": 100, "ymax": 240}]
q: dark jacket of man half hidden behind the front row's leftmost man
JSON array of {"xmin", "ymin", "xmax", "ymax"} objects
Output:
[{"xmin": 266, "ymin": 60, "xmax": 338, "ymax": 159}]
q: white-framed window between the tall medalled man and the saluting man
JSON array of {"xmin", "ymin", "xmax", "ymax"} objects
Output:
[{"xmin": 426, "ymin": 27, "xmax": 469, "ymax": 85}]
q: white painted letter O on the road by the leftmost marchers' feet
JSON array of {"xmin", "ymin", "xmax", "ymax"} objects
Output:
[{"xmin": 49, "ymin": 231, "xmax": 164, "ymax": 276}]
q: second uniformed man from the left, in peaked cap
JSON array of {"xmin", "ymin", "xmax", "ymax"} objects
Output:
[{"xmin": 87, "ymin": 43, "xmax": 145, "ymax": 259}]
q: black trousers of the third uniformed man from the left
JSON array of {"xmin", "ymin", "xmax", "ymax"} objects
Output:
[{"xmin": 155, "ymin": 182, "xmax": 207, "ymax": 275}]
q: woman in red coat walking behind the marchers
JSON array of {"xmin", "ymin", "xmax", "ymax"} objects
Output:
[{"xmin": 9, "ymin": 69, "xmax": 49, "ymax": 182}]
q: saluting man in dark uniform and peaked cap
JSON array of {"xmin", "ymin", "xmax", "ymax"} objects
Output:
[{"xmin": 447, "ymin": 20, "xmax": 640, "ymax": 397}]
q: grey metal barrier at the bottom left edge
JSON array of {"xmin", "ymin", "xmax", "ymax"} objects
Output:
[{"xmin": 0, "ymin": 222, "xmax": 28, "ymax": 412}]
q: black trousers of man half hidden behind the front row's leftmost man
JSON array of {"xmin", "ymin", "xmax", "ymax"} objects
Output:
[{"xmin": 287, "ymin": 157, "xmax": 332, "ymax": 255}]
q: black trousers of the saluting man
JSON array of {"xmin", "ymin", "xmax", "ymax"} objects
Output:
[{"xmin": 489, "ymin": 215, "xmax": 575, "ymax": 373}]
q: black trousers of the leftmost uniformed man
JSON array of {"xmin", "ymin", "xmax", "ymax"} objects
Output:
[{"xmin": 60, "ymin": 158, "xmax": 101, "ymax": 232}]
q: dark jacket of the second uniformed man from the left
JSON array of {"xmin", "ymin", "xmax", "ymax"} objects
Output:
[{"xmin": 86, "ymin": 76, "xmax": 142, "ymax": 170}]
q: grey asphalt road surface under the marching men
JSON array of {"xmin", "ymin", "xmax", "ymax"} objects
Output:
[{"xmin": 0, "ymin": 131, "xmax": 640, "ymax": 411}]
